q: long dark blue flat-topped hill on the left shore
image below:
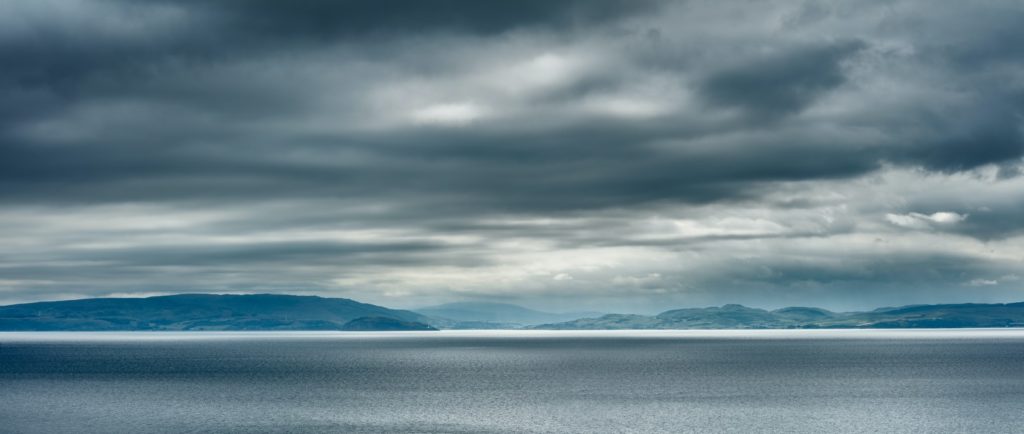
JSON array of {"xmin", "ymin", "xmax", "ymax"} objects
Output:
[{"xmin": 0, "ymin": 294, "xmax": 435, "ymax": 331}]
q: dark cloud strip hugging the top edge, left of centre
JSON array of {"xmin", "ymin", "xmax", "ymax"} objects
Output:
[{"xmin": 171, "ymin": 0, "xmax": 659, "ymax": 38}]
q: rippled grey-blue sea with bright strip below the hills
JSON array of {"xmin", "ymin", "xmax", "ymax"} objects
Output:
[{"xmin": 0, "ymin": 329, "xmax": 1024, "ymax": 433}]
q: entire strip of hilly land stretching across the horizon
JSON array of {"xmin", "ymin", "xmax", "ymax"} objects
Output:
[{"xmin": 0, "ymin": 294, "xmax": 1024, "ymax": 331}]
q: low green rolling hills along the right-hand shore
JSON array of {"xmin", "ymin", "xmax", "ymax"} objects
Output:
[{"xmin": 534, "ymin": 303, "xmax": 1024, "ymax": 330}]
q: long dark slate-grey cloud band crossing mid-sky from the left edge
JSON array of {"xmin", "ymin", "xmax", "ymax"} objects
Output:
[{"xmin": 0, "ymin": 117, "xmax": 877, "ymax": 212}]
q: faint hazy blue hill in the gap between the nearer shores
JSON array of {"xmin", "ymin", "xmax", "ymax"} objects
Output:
[{"xmin": 416, "ymin": 302, "xmax": 595, "ymax": 327}]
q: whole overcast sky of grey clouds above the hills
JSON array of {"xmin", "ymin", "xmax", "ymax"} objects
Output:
[{"xmin": 0, "ymin": 0, "xmax": 1024, "ymax": 313}]
